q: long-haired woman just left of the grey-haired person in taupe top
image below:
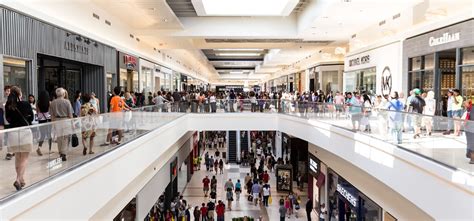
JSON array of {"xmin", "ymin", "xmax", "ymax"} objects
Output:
[{"xmin": 36, "ymin": 91, "xmax": 53, "ymax": 156}]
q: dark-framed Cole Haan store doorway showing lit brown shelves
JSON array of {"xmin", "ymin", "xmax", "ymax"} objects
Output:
[{"xmin": 436, "ymin": 49, "xmax": 456, "ymax": 116}]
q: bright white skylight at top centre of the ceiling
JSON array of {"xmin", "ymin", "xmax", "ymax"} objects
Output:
[{"xmin": 192, "ymin": 0, "xmax": 299, "ymax": 16}]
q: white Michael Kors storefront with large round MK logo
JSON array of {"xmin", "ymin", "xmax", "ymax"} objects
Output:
[{"xmin": 343, "ymin": 41, "xmax": 403, "ymax": 95}]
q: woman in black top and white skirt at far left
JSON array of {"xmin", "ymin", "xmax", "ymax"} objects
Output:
[{"xmin": 5, "ymin": 86, "xmax": 34, "ymax": 191}]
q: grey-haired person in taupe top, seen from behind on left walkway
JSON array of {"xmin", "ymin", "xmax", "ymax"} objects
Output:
[{"xmin": 49, "ymin": 88, "xmax": 74, "ymax": 161}]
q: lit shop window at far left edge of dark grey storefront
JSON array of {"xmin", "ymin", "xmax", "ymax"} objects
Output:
[{"xmin": 3, "ymin": 58, "xmax": 27, "ymax": 95}]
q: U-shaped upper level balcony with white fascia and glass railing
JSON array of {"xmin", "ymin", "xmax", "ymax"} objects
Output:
[{"xmin": 0, "ymin": 101, "xmax": 474, "ymax": 220}]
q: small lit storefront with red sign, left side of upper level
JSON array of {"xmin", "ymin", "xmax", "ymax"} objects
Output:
[{"xmin": 117, "ymin": 51, "xmax": 139, "ymax": 92}]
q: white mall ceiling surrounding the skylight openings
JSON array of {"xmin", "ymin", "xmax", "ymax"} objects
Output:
[{"xmin": 7, "ymin": 0, "xmax": 473, "ymax": 82}]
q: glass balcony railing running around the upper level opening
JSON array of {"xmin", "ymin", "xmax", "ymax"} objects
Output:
[{"xmin": 0, "ymin": 100, "xmax": 474, "ymax": 200}]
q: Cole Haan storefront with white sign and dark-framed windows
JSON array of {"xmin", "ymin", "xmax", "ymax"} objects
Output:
[{"xmin": 403, "ymin": 19, "xmax": 474, "ymax": 115}]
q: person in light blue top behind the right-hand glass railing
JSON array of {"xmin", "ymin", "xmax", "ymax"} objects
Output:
[{"xmin": 386, "ymin": 91, "xmax": 404, "ymax": 144}]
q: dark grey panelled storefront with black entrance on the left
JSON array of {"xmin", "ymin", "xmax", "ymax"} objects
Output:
[{"xmin": 0, "ymin": 7, "xmax": 117, "ymax": 111}]
